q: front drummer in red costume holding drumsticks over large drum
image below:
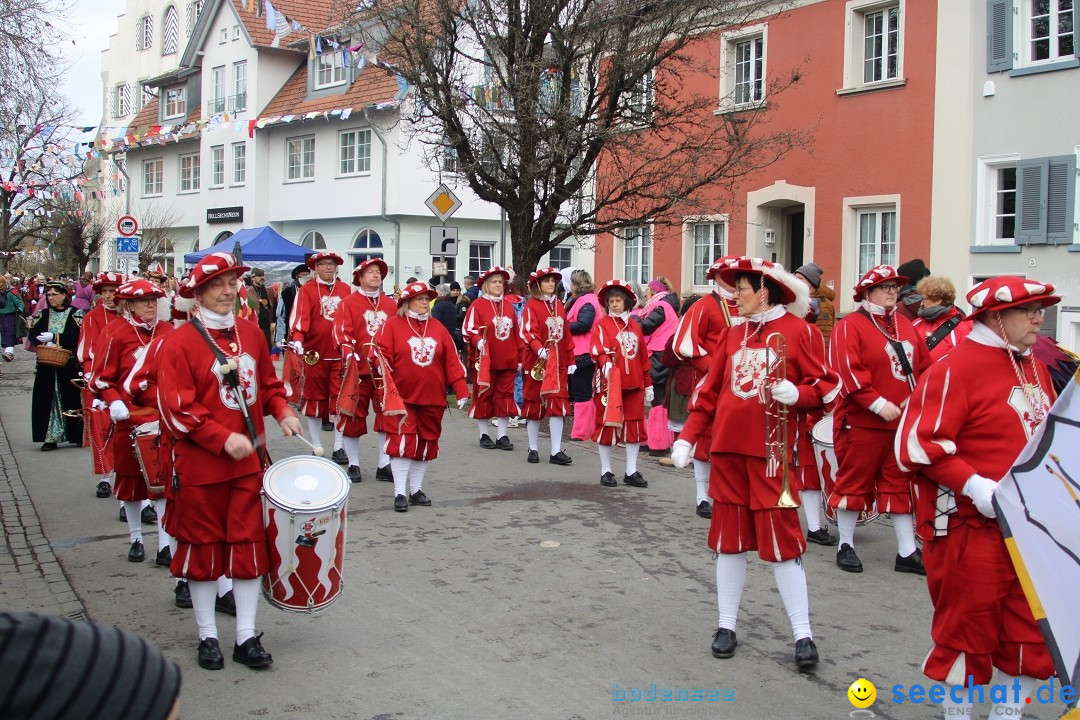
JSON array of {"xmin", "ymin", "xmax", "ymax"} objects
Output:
[{"xmin": 158, "ymin": 253, "xmax": 300, "ymax": 669}]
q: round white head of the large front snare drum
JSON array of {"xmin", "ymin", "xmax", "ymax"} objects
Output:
[{"xmin": 262, "ymin": 456, "xmax": 350, "ymax": 513}]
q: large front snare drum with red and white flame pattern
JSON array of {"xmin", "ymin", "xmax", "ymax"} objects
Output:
[{"xmin": 262, "ymin": 456, "xmax": 352, "ymax": 613}]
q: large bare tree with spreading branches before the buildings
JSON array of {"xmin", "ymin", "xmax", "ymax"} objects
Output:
[{"xmin": 352, "ymin": 0, "xmax": 808, "ymax": 271}]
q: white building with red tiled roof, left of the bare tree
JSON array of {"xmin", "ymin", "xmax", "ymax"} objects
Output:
[{"xmin": 111, "ymin": 0, "xmax": 592, "ymax": 285}]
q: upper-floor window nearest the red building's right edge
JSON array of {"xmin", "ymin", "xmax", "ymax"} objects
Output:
[{"xmin": 843, "ymin": 0, "xmax": 907, "ymax": 91}]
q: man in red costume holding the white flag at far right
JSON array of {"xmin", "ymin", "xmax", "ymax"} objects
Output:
[{"xmin": 895, "ymin": 276, "xmax": 1061, "ymax": 718}]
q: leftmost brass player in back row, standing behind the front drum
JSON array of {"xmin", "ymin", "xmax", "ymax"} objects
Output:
[{"xmin": 288, "ymin": 253, "xmax": 349, "ymax": 455}]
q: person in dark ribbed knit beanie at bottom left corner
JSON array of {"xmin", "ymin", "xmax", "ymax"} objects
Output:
[{"xmin": 0, "ymin": 612, "xmax": 180, "ymax": 720}]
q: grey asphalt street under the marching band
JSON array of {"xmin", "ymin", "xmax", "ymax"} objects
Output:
[{"xmin": 0, "ymin": 350, "xmax": 1062, "ymax": 720}]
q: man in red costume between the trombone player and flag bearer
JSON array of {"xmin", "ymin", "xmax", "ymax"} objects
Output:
[{"xmin": 828, "ymin": 266, "xmax": 930, "ymax": 574}]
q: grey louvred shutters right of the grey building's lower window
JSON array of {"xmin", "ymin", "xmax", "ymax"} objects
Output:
[{"xmin": 1016, "ymin": 154, "xmax": 1077, "ymax": 245}]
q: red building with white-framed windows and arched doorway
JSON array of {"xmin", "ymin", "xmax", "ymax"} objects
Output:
[{"xmin": 595, "ymin": 0, "xmax": 937, "ymax": 309}]
